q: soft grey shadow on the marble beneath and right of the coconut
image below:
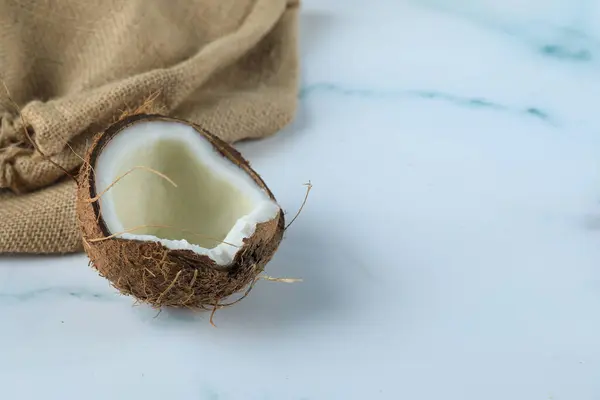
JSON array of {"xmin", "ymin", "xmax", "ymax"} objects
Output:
[{"xmin": 137, "ymin": 221, "xmax": 345, "ymax": 334}]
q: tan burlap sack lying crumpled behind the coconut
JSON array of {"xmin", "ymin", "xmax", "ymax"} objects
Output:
[{"xmin": 0, "ymin": 0, "xmax": 298, "ymax": 253}]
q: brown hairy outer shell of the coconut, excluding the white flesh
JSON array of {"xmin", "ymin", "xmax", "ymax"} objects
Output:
[{"xmin": 77, "ymin": 114, "xmax": 285, "ymax": 309}]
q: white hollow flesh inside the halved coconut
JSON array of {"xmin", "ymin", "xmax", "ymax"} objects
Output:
[{"xmin": 94, "ymin": 121, "xmax": 279, "ymax": 266}]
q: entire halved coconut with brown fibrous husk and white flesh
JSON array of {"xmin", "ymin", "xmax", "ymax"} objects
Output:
[{"xmin": 77, "ymin": 114, "xmax": 284, "ymax": 308}]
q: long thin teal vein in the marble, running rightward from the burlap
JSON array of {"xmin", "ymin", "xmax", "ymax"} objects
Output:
[{"xmin": 299, "ymin": 83, "xmax": 556, "ymax": 125}]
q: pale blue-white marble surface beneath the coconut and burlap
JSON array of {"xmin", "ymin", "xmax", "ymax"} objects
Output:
[{"xmin": 0, "ymin": 0, "xmax": 600, "ymax": 400}]
